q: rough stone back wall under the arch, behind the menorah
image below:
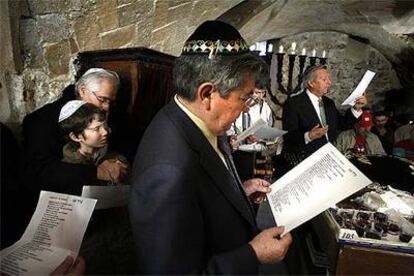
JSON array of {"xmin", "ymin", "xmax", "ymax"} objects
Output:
[{"xmin": 271, "ymin": 32, "xmax": 400, "ymax": 128}]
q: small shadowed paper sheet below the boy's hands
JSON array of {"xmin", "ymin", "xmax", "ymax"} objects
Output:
[{"xmin": 82, "ymin": 185, "xmax": 131, "ymax": 210}]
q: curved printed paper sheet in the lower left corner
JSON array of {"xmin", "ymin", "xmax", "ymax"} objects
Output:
[{"xmin": 1, "ymin": 191, "xmax": 96, "ymax": 275}]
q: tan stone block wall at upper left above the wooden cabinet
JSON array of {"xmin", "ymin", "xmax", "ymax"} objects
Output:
[{"xmin": 1, "ymin": 0, "xmax": 242, "ymax": 126}]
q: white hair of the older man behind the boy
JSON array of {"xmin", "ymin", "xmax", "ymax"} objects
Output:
[{"xmin": 75, "ymin": 68, "xmax": 119, "ymax": 95}]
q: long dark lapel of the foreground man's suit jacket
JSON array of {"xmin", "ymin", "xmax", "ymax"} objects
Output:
[{"xmin": 166, "ymin": 100, "xmax": 256, "ymax": 226}]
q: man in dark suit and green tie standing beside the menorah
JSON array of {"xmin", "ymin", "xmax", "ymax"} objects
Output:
[{"xmin": 282, "ymin": 65, "xmax": 367, "ymax": 164}]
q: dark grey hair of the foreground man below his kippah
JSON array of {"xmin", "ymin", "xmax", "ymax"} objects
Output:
[{"xmin": 173, "ymin": 53, "xmax": 269, "ymax": 101}]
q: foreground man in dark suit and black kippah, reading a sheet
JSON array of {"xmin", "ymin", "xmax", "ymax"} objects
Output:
[{"xmin": 129, "ymin": 21, "xmax": 291, "ymax": 274}]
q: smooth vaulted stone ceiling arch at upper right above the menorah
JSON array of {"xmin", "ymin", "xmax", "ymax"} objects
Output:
[{"xmin": 220, "ymin": 0, "xmax": 414, "ymax": 85}]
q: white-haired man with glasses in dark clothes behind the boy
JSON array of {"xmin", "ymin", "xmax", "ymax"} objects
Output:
[{"xmin": 23, "ymin": 68, "xmax": 127, "ymax": 211}]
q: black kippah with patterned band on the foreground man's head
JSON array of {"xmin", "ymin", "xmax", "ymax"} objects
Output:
[{"xmin": 182, "ymin": 20, "xmax": 249, "ymax": 56}]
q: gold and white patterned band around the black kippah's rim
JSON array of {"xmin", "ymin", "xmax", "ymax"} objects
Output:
[{"xmin": 182, "ymin": 39, "xmax": 249, "ymax": 55}]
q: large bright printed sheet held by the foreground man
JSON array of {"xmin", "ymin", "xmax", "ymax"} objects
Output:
[{"xmin": 267, "ymin": 143, "xmax": 372, "ymax": 233}]
